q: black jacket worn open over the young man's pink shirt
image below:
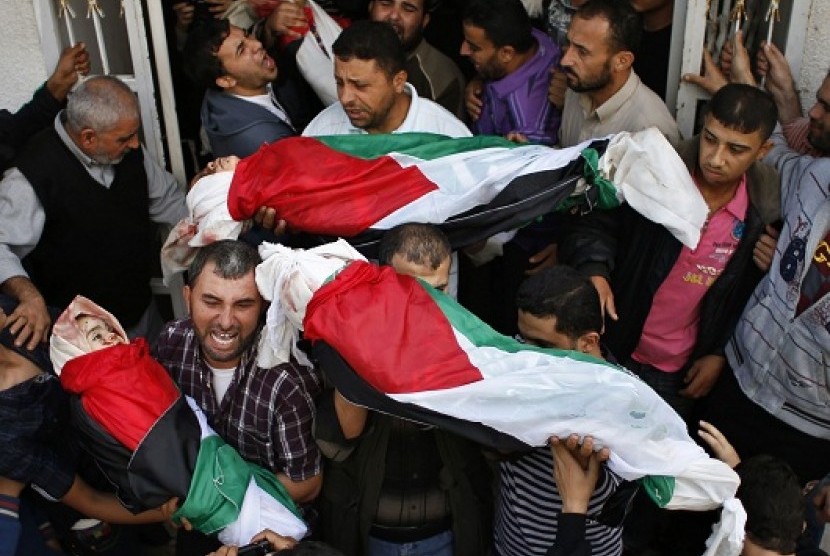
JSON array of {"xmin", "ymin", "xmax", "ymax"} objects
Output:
[{"xmin": 559, "ymin": 137, "xmax": 781, "ymax": 366}]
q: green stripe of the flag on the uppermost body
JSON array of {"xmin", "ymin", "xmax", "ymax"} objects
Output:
[{"xmin": 315, "ymin": 133, "xmax": 526, "ymax": 160}]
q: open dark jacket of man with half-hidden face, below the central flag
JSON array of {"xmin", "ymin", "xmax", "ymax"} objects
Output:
[{"xmin": 314, "ymin": 392, "xmax": 492, "ymax": 556}]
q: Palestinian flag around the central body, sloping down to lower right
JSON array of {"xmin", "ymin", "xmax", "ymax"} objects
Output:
[{"xmin": 304, "ymin": 262, "xmax": 738, "ymax": 509}]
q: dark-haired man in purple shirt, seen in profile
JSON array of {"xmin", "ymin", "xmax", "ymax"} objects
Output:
[{"xmin": 461, "ymin": 0, "xmax": 560, "ymax": 145}]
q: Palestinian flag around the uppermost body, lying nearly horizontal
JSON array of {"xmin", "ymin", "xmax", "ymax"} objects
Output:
[{"xmin": 227, "ymin": 133, "xmax": 618, "ymax": 252}]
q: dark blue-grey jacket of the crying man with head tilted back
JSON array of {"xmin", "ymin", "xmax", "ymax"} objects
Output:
[{"xmin": 202, "ymin": 89, "xmax": 296, "ymax": 158}]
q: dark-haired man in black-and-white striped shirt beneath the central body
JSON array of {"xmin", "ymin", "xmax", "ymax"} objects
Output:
[{"xmin": 494, "ymin": 266, "xmax": 622, "ymax": 556}]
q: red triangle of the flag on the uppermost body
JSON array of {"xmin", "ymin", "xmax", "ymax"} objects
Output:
[{"xmin": 228, "ymin": 137, "xmax": 437, "ymax": 236}]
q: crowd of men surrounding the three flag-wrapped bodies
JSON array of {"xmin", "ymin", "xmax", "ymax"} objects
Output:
[{"xmin": 0, "ymin": 0, "xmax": 830, "ymax": 556}]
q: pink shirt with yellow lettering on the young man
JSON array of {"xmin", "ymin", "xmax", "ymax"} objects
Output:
[{"xmin": 631, "ymin": 175, "xmax": 749, "ymax": 373}]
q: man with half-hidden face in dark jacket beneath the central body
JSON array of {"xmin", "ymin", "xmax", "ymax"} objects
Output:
[{"xmin": 315, "ymin": 224, "xmax": 491, "ymax": 556}]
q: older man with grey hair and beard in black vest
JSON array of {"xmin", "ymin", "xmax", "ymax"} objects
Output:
[{"xmin": 0, "ymin": 77, "xmax": 187, "ymax": 348}]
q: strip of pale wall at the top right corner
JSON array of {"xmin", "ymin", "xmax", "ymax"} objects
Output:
[{"xmin": 795, "ymin": 0, "xmax": 830, "ymax": 110}]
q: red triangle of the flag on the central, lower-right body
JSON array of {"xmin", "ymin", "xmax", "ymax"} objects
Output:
[{"xmin": 303, "ymin": 261, "xmax": 482, "ymax": 394}]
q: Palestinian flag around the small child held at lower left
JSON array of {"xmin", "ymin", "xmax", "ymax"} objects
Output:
[{"xmin": 60, "ymin": 338, "xmax": 307, "ymax": 545}]
